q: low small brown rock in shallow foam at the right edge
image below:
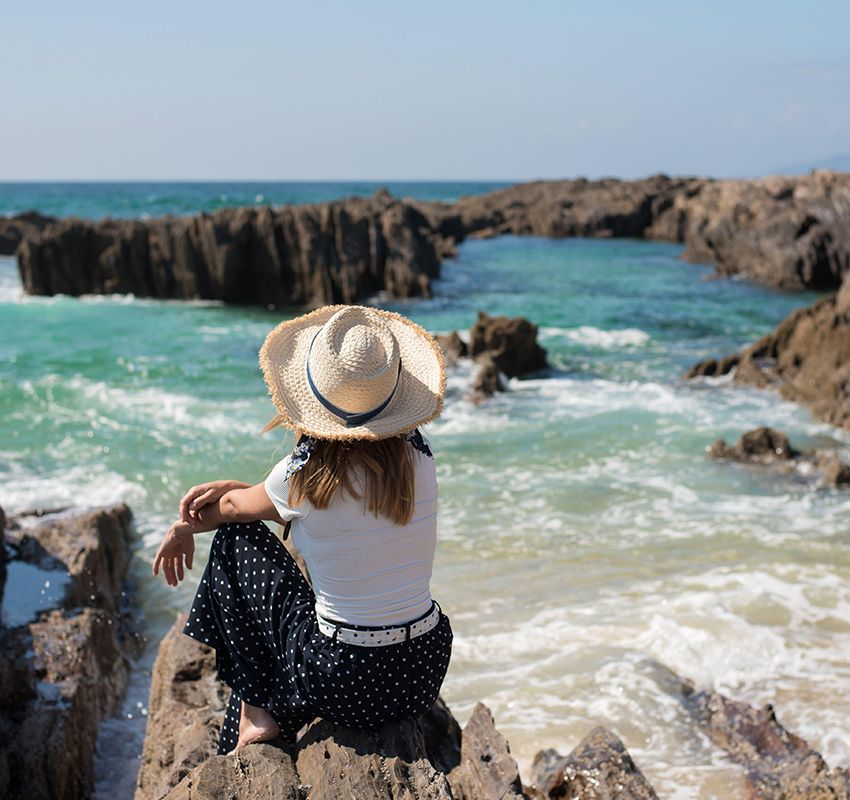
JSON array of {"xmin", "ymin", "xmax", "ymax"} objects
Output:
[{"xmin": 708, "ymin": 427, "xmax": 850, "ymax": 486}]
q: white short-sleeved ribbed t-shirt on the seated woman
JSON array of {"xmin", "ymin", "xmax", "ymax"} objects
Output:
[{"xmin": 264, "ymin": 445, "xmax": 437, "ymax": 625}]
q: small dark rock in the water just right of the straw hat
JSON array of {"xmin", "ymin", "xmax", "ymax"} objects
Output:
[{"xmin": 469, "ymin": 311, "xmax": 548, "ymax": 377}]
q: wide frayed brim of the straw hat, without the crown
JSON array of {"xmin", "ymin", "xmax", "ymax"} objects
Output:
[{"xmin": 259, "ymin": 305, "xmax": 446, "ymax": 439}]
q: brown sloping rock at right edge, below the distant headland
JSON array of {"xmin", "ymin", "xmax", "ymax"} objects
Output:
[{"xmin": 683, "ymin": 288, "xmax": 850, "ymax": 429}]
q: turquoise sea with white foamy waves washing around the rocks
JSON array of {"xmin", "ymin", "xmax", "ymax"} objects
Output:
[{"xmin": 0, "ymin": 182, "xmax": 850, "ymax": 800}]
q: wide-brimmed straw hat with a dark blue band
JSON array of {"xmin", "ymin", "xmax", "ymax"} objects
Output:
[{"xmin": 260, "ymin": 305, "xmax": 446, "ymax": 439}]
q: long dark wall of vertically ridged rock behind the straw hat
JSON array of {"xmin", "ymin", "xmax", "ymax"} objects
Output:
[{"xmin": 17, "ymin": 194, "xmax": 440, "ymax": 306}]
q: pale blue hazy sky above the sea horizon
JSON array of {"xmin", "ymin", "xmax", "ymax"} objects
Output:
[{"xmin": 0, "ymin": 0, "xmax": 850, "ymax": 181}]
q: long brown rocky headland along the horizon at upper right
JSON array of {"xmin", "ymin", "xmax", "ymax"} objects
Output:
[{"xmin": 418, "ymin": 171, "xmax": 850, "ymax": 289}]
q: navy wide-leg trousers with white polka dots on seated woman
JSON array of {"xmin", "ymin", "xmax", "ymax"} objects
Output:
[{"xmin": 183, "ymin": 520, "xmax": 452, "ymax": 753}]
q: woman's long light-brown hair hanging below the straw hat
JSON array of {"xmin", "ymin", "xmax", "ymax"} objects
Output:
[{"xmin": 263, "ymin": 417, "xmax": 415, "ymax": 525}]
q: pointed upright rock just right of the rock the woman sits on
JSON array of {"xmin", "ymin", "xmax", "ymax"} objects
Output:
[{"xmin": 448, "ymin": 703, "xmax": 525, "ymax": 800}]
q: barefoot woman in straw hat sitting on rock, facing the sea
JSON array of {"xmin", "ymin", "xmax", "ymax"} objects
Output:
[{"xmin": 153, "ymin": 306, "xmax": 452, "ymax": 753}]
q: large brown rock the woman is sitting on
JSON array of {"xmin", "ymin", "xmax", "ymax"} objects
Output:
[{"xmin": 141, "ymin": 613, "xmax": 470, "ymax": 800}]
